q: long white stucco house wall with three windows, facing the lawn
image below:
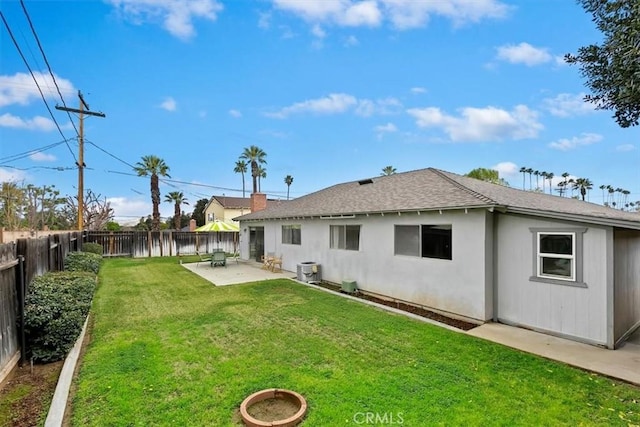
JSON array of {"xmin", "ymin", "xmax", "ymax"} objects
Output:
[{"xmin": 241, "ymin": 210, "xmax": 493, "ymax": 320}]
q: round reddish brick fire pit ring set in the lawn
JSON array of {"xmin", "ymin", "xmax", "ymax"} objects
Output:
[{"xmin": 240, "ymin": 388, "xmax": 307, "ymax": 427}]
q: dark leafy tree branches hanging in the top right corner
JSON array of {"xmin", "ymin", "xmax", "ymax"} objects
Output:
[{"xmin": 565, "ymin": 0, "xmax": 640, "ymax": 128}]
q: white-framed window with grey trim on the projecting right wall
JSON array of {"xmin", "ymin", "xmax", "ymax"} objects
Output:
[{"xmin": 531, "ymin": 228, "xmax": 586, "ymax": 287}]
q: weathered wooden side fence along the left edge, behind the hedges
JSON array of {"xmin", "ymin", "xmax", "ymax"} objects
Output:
[{"xmin": 0, "ymin": 232, "xmax": 82, "ymax": 379}]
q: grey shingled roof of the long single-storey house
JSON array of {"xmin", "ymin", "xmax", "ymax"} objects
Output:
[{"xmin": 235, "ymin": 168, "xmax": 640, "ymax": 229}]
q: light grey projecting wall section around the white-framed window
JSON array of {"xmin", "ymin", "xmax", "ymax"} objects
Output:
[{"xmin": 495, "ymin": 214, "xmax": 613, "ymax": 346}]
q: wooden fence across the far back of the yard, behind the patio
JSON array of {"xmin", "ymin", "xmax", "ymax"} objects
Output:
[{"xmin": 84, "ymin": 231, "xmax": 238, "ymax": 258}]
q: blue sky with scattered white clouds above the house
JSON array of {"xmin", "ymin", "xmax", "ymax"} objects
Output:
[{"xmin": 0, "ymin": 0, "xmax": 640, "ymax": 221}]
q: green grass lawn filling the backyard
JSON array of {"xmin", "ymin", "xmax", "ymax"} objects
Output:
[{"xmin": 72, "ymin": 258, "xmax": 640, "ymax": 427}]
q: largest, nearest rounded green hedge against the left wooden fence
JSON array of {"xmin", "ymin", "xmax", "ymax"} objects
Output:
[{"xmin": 24, "ymin": 272, "xmax": 96, "ymax": 362}]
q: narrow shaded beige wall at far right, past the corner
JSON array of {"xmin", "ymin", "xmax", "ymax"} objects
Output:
[{"xmin": 613, "ymin": 230, "xmax": 640, "ymax": 342}]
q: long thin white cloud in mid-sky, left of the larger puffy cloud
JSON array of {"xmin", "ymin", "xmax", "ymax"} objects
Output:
[{"xmin": 264, "ymin": 93, "xmax": 402, "ymax": 119}]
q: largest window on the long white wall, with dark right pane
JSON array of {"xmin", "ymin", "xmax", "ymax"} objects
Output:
[{"xmin": 394, "ymin": 224, "xmax": 453, "ymax": 259}]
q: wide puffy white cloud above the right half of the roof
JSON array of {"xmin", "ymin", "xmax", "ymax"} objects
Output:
[{"xmin": 407, "ymin": 105, "xmax": 544, "ymax": 142}]
